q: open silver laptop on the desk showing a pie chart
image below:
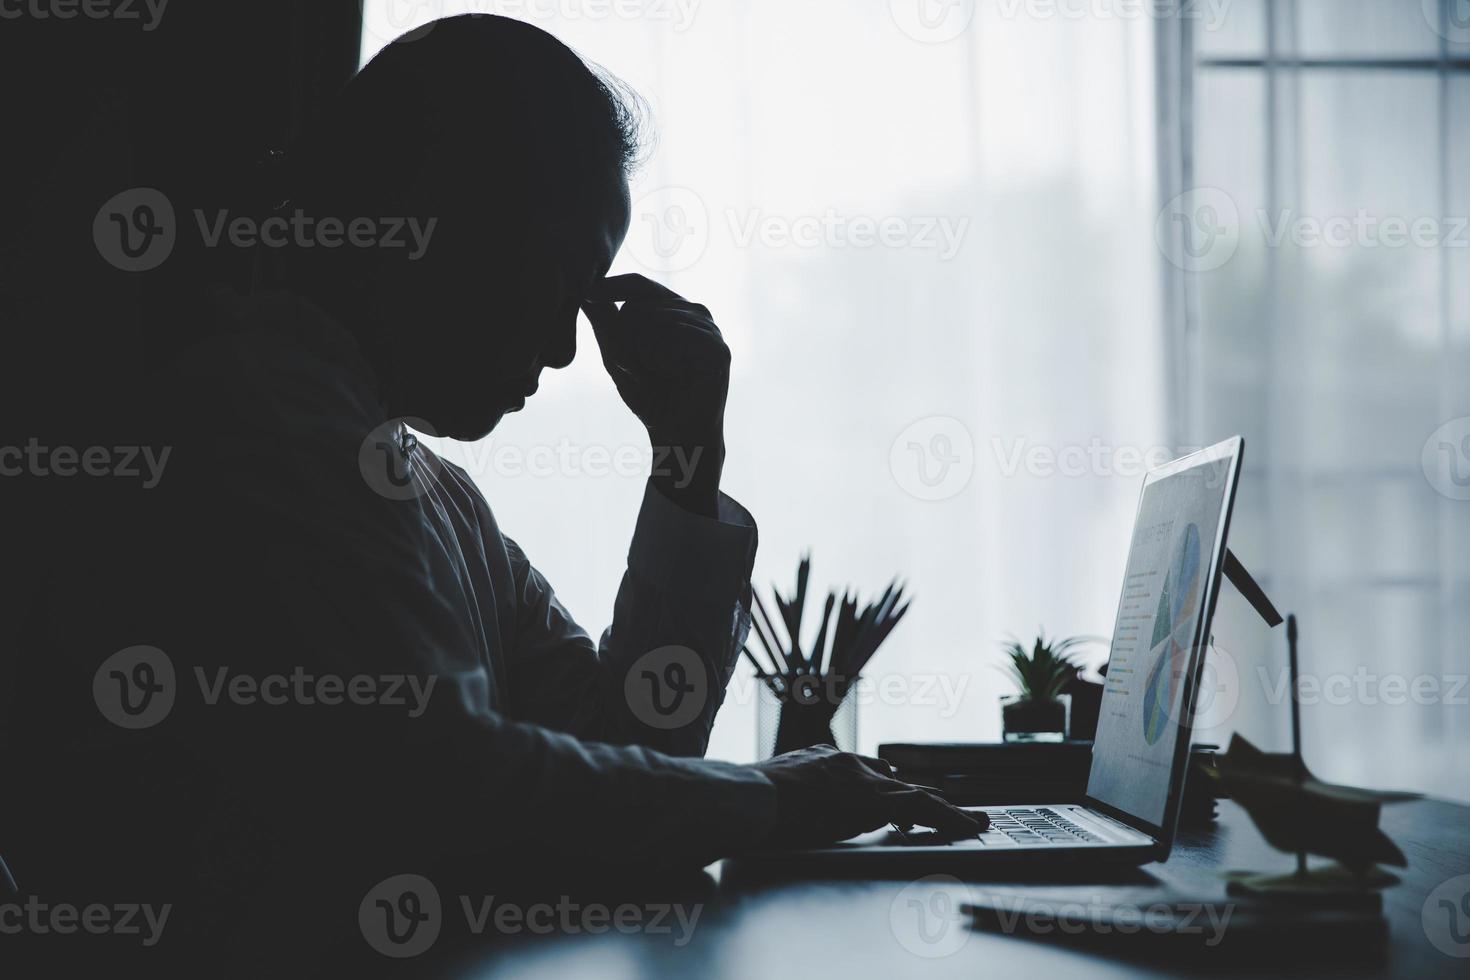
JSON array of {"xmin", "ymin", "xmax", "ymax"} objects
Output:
[{"xmin": 753, "ymin": 438, "xmax": 1245, "ymax": 868}]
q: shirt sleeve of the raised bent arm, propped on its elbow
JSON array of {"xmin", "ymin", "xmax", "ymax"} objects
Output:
[{"xmin": 507, "ymin": 483, "xmax": 757, "ymax": 757}]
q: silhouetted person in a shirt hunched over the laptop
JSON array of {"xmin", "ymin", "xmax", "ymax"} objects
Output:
[{"xmin": 13, "ymin": 16, "xmax": 975, "ymax": 969}]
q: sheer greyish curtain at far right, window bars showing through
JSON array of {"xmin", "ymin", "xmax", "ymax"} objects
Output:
[{"xmin": 1180, "ymin": 0, "xmax": 1470, "ymax": 799}]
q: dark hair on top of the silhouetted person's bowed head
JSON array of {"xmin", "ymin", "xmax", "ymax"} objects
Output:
[{"xmin": 294, "ymin": 15, "xmax": 648, "ymax": 227}]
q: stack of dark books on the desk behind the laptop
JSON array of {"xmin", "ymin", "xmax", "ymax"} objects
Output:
[{"xmin": 878, "ymin": 741, "xmax": 1216, "ymax": 827}]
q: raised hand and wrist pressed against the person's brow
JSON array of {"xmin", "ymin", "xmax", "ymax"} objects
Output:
[{"xmin": 582, "ymin": 275, "xmax": 731, "ymax": 517}]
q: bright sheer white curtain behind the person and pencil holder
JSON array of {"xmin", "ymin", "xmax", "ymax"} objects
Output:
[{"xmin": 365, "ymin": 0, "xmax": 1167, "ymax": 760}]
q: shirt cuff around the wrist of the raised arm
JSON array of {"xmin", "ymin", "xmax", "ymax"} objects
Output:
[{"xmin": 628, "ymin": 482, "xmax": 759, "ymax": 602}]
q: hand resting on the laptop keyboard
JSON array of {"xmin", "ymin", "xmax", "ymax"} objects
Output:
[{"xmin": 754, "ymin": 745, "xmax": 985, "ymax": 848}]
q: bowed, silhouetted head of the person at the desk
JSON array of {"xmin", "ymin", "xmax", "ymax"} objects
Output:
[{"xmin": 293, "ymin": 15, "xmax": 639, "ymax": 439}]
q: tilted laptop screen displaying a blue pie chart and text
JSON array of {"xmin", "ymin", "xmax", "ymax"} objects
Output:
[{"xmin": 1088, "ymin": 451, "xmax": 1235, "ymax": 827}]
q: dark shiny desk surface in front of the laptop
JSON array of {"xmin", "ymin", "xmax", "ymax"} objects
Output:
[{"xmin": 454, "ymin": 801, "xmax": 1470, "ymax": 980}]
